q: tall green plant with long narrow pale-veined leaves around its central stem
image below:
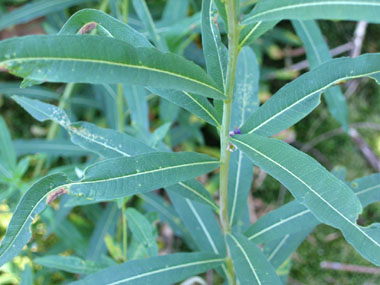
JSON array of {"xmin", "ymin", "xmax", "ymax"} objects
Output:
[{"xmin": 0, "ymin": 0, "xmax": 380, "ymax": 284}]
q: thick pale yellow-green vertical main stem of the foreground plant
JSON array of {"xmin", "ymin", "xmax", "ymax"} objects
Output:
[{"xmin": 219, "ymin": 0, "xmax": 240, "ymax": 284}]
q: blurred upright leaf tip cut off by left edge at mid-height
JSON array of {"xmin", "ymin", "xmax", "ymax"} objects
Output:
[{"xmin": 0, "ymin": 116, "xmax": 17, "ymax": 172}]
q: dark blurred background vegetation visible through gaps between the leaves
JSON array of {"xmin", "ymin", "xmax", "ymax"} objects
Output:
[{"xmin": 0, "ymin": 0, "xmax": 380, "ymax": 285}]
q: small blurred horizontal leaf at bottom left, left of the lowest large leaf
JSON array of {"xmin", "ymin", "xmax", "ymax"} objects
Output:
[{"xmin": 33, "ymin": 255, "xmax": 106, "ymax": 274}]
